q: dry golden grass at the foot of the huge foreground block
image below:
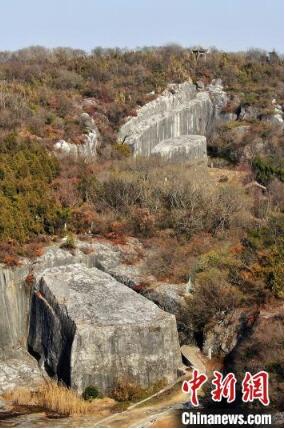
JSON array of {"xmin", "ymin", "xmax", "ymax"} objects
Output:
[{"xmin": 4, "ymin": 381, "xmax": 115, "ymax": 416}]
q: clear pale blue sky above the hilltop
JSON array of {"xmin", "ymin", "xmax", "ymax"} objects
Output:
[{"xmin": 0, "ymin": 0, "xmax": 283, "ymax": 53}]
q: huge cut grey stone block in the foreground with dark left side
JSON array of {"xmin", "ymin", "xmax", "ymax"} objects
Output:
[{"xmin": 28, "ymin": 264, "xmax": 181, "ymax": 393}]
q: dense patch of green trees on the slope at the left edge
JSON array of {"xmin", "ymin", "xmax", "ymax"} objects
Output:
[{"xmin": 0, "ymin": 135, "xmax": 68, "ymax": 242}]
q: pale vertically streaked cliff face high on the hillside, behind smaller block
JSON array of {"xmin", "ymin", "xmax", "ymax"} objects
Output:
[{"xmin": 119, "ymin": 81, "xmax": 226, "ymax": 161}]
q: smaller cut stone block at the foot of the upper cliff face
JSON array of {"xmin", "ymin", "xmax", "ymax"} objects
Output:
[{"xmin": 151, "ymin": 135, "xmax": 207, "ymax": 163}]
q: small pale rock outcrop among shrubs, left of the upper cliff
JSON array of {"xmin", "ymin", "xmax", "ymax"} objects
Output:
[{"xmin": 54, "ymin": 113, "xmax": 100, "ymax": 159}]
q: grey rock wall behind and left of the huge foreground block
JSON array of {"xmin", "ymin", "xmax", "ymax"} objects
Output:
[{"xmin": 0, "ymin": 240, "xmax": 146, "ymax": 358}]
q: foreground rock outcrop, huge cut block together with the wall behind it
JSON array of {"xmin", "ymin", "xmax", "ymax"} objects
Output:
[{"xmin": 0, "ymin": 239, "xmax": 181, "ymax": 392}]
